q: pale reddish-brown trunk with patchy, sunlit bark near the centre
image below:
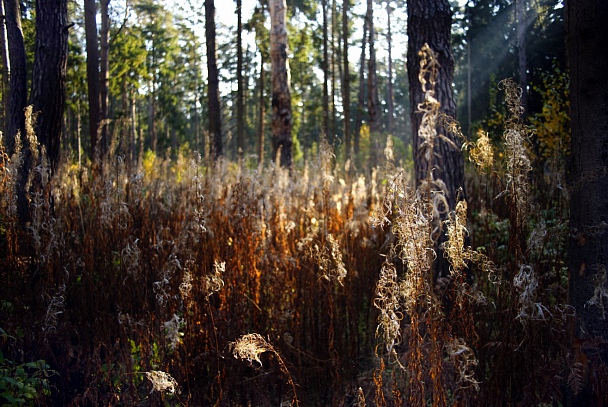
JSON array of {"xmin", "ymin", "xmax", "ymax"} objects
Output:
[{"xmin": 269, "ymin": 0, "xmax": 292, "ymax": 168}]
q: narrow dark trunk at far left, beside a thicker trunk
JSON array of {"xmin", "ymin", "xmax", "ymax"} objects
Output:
[{"xmin": 4, "ymin": 0, "xmax": 27, "ymax": 154}]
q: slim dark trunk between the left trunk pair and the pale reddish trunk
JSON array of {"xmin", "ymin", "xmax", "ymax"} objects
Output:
[{"xmin": 205, "ymin": 0, "xmax": 224, "ymax": 159}]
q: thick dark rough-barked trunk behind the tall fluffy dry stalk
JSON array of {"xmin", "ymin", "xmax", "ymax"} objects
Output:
[{"xmin": 407, "ymin": 0, "xmax": 466, "ymax": 276}]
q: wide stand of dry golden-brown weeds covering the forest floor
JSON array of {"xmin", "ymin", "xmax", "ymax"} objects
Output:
[{"xmin": 0, "ymin": 49, "xmax": 576, "ymax": 406}]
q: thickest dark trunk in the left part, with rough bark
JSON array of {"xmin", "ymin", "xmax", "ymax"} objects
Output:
[{"xmin": 30, "ymin": 0, "xmax": 68, "ymax": 173}]
